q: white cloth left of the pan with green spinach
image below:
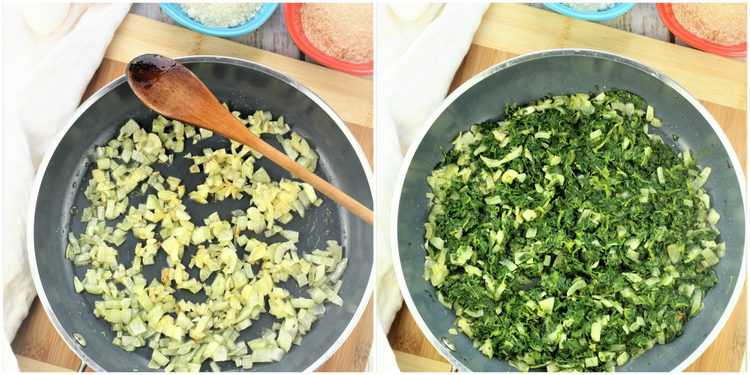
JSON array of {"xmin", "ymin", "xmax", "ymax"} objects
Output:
[{"xmin": 375, "ymin": 3, "xmax": 488, "ymax": 373}]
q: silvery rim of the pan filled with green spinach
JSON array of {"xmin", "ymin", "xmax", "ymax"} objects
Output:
[{"xmin": 387, "ymin": 48, "xmax": 750, "ymax": 372}]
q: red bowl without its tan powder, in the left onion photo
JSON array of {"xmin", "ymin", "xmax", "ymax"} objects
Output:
[{"xmin": 284, "ymin": 3, "xmax": 372, "ymax": 76}]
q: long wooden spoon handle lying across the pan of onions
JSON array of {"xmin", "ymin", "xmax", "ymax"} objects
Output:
[{"xmin": 221, "ymin": 116, "xmax": 373, "ymax": 224}]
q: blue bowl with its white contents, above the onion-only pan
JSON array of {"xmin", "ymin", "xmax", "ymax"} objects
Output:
[{"xmin": 160, "ymin": 3, "xmax": 278, "ymax": 37}]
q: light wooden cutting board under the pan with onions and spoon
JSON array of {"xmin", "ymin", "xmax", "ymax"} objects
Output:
[{"xmin": 12, "ymin": 14, "xmax": 373, "ymax": 372}]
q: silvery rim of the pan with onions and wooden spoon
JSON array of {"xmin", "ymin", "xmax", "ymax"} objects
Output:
[{"xmin": 26, "ymin": 55, "xmax": 375, "ymax": 373}]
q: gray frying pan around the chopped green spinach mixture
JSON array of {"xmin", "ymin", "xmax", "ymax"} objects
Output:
[{"xmin": 391, "ymin": 49, "xmax": 745, "ymax": 372}]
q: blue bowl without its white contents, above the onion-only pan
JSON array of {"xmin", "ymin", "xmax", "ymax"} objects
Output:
[{"xmin": 160, "ymin": 3, "xmax": 279, "ymax": 37}]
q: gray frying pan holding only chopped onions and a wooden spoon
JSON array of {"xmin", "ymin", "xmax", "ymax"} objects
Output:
[{"xmin": 27, "ymin": 56, "xmax": 373, "ymax": 372}]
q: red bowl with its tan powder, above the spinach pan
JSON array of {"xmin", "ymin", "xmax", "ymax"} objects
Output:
[{"xmin": 656, "ymin": 3, "xmax": 747, "ymax": 57}]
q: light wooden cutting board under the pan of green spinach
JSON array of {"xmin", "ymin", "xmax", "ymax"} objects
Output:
[{"xmin": 388, "ymin": 4, "xmax": 747, "ymax": 372}]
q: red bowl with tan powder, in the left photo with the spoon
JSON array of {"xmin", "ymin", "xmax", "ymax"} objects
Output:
[{"xmin": 284, "ymin": 3, "xmax": 373, "ymax": 75}]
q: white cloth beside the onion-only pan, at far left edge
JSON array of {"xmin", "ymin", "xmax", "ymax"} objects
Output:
[{"xmin": 0, "ymin": 2, "xmax": 130, "ymax": 372}]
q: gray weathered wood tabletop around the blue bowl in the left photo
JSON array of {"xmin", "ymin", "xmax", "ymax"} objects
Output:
[{"xmin": 130, "ymin": 3, "xmax": 304, "ymax": 60}]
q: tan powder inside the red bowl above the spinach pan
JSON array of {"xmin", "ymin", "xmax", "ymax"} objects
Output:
[{"xmin": 672, "ymin": 3, "xmax": 747, "ymax": 46}]
